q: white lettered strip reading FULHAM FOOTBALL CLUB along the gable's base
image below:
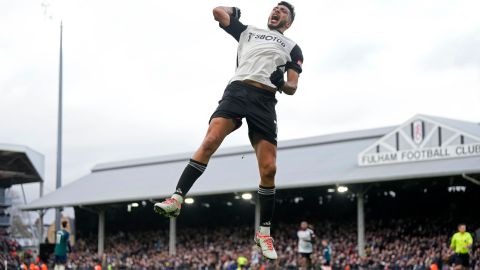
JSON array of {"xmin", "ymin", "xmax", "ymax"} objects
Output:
[{"xmin": 358, "ymin": 143, "xmax": 480, "ymax": 166}]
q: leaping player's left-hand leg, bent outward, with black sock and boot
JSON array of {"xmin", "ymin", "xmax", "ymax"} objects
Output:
[{"xmin": 154, "ymin": 117, "xmax": 236, "ymax": 217}]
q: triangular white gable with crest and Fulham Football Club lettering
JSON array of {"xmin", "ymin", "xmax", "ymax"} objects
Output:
[{"xmin": 358, "ymin": 115, "xmax": 480, "ymax": 166}]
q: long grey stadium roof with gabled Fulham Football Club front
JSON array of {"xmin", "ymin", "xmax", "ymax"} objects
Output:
[{"xmin": 23, "ymin": 115, "xmax": 480, "ymax": 210}]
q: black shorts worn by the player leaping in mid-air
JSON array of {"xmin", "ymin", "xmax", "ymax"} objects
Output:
[{"xmin": 210, "ymin": 81, "xmax": 277, "ymax": 145}]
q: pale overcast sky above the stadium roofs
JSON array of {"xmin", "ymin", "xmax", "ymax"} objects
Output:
[{"xmin": 0, "ymin": 0, "xmax": 480, "ymax": 217}]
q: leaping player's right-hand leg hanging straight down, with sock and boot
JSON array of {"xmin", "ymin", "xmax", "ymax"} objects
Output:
[{"xmin": 252, "ymin": 134, "xmax": 277, "ymax": 260}]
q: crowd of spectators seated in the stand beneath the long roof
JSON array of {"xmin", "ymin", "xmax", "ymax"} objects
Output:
[{"xmin": 51, "ymin": 220, "xmax": 480, "ymax": 270}]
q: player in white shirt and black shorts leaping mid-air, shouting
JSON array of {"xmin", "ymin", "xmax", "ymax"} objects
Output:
[{"xmin": 154, "ymin": 1, "xmax": 303, "ymax": 259}]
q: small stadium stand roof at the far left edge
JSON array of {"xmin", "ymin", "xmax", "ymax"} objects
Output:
[{"xmin": 0, "ymin": 144, "xmax": 44, "ymax": 187}]
